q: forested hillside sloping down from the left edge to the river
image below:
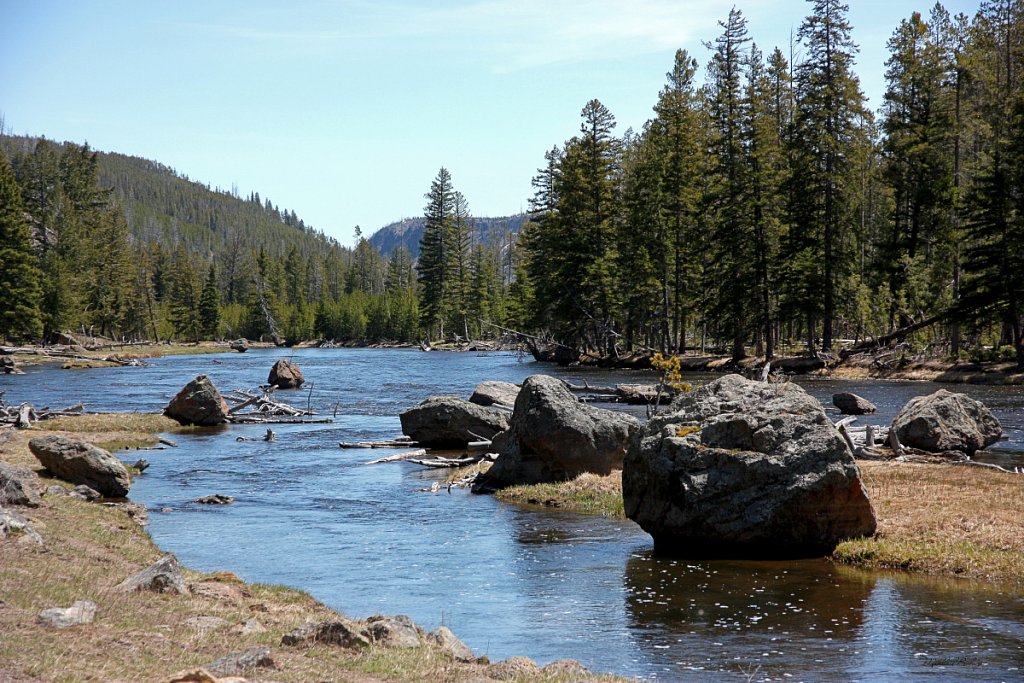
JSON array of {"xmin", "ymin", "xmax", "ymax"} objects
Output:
[{"xmin": 0, "ymin": 137, "xmax": 419, "ymax": 342}]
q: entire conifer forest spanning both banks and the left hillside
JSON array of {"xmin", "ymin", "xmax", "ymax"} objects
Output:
[{"xmin": 0, "ymin": 0, "xmax": 1024, "ymax": 367}]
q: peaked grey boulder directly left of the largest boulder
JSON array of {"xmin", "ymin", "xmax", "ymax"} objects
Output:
[{"xmin": 478, "ymin": 375, "xmax": 640, "ymax": 489}]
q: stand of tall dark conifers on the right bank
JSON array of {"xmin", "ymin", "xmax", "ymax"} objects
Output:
[{"xmin": 509, "ymin": 0, "xmax": 1024, "ymax": 366}]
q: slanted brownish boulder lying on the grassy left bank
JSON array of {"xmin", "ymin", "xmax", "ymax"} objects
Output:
[{"xmin": 29, "ymin": 436, "xmax": 131, "ymax": 498}]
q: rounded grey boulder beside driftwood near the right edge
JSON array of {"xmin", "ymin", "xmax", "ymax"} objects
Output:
[{"xmin": 892, "ymin": 389, "xmax": 1002, "ymax": 455}]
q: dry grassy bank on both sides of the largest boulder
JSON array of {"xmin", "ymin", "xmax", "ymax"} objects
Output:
[{"xmin": 496, "ymin": 460, "xmax": 1024, "ymax": 589}]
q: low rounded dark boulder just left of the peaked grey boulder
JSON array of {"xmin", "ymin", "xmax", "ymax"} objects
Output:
[{"xmin": 398, "ymin": 396, "xmax": 509, "ymax": 449}]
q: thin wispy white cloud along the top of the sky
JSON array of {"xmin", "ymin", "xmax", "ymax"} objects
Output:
[{"xmin": 178, "ymin": 0, "xmax": 769, "ymax": 73}]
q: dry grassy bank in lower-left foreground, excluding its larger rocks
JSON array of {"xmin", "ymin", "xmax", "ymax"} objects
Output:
[{"xmin": 0, "ymin": 415, "xmax": 625, "ymax": 683}]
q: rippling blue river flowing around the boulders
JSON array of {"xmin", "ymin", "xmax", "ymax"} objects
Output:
[{"xmin": 0, "ymin": 349, "xmax": 1024, "ymax": 681}]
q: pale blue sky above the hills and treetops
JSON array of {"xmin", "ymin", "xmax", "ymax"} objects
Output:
[{"xmin": 0, "ymin": 0, "xmax": 978, "ymax": 245}]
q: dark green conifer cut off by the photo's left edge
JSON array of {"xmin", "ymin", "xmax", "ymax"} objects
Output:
[{"xmin": 0, "ymin": 151, "xmax": 43, "ymax": 339}]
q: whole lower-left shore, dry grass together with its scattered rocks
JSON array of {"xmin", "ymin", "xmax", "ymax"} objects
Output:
[{"xmin": 0, "ymin": 416, "xmax": 623, "ymax": 683}]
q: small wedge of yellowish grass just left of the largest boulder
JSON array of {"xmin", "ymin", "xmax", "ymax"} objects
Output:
[{"xmin": 496, "ymin": 470, "xmax": 626, "ymax": 518}]
